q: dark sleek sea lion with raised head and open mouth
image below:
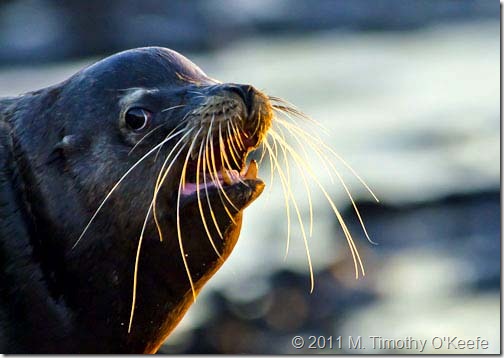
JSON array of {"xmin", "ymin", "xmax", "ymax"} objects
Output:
[{"xmin": 0, "ymin": 47, "xmax": 272, "ymax": 353}]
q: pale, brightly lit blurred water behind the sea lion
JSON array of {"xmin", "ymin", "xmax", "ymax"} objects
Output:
[{"xmin": 0, "ymin": 22, "xmax": 500, "ymax": 353}]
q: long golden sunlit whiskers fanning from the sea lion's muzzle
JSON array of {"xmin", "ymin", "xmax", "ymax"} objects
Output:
[{"xmin": 74, "ymin": 92, "xmax": 378, "ymax": 332}]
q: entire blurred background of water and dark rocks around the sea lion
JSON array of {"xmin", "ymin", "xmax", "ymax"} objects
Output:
[{"xmin": 0, "ymin": 0, "xmax": 500, "ymax": 354}]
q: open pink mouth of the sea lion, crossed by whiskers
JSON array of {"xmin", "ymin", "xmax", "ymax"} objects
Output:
[{"xmin": 181, "ymin": 137, "xmax": 260, "ymax": 196}]
